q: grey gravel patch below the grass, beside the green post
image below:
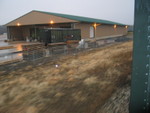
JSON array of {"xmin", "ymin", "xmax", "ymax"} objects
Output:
[{"xmin": 97, "ymin": 85, "xmax": 130, "ymax": 113}]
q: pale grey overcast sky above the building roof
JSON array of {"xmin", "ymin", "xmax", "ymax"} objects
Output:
[{"xmin": 0, "ymin": 0, "xmax": 134, "ymax": 25}]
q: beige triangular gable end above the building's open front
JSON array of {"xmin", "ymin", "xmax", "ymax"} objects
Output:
[{"xmin": 6, "ymin": 11, "xmax": 77, "ymax": 26}]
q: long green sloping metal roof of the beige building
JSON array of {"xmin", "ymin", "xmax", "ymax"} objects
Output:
[{"xmin": 33, "ymin": 10, "xmax": 124, "ymax": 25}]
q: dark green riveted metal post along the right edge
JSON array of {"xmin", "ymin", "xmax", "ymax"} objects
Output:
[{"xmin": 129, "ymin": 0, "xmax": 150, "ymax": 113}]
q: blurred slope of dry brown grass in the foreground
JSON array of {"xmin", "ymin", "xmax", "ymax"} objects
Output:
[{"xmin": 0, "ymin": 42, "xmax": 132, "ymax": 113}]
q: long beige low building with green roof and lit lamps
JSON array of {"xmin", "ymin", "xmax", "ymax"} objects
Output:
[{"xmin": 6, "ymin": 11, "xmax": 128, "ymax": 41}]
